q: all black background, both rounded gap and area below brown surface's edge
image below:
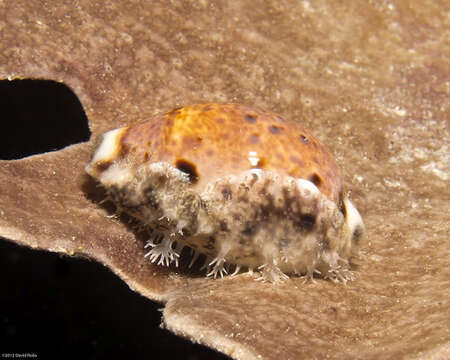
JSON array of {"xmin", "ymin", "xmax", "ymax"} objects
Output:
[{"xmin": 0, "ymin": 80, "xmax": 229, "ymax": 360}]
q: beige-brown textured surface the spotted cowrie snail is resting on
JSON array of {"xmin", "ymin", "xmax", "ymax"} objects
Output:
[{"xmin": 0, "ymin": 0, "xmax": 450, "ymax": 359}]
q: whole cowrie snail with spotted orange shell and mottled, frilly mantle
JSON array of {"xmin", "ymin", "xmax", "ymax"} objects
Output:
[{"xmin": 86, "ymin": 103, "xmax": 364, "ymax": 282}]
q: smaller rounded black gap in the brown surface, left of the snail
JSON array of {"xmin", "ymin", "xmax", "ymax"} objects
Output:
[{"xmin": 0, "ymin": 80, "xmax": 91, "ymax": 160}]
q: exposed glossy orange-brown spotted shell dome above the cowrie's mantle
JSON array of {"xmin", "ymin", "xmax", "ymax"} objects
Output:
[{"xmin": 120, "ymin": 103, "xmax": 342, "ymax": 203}]
